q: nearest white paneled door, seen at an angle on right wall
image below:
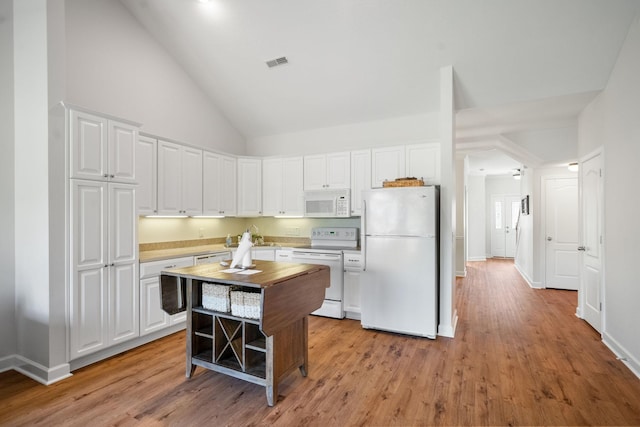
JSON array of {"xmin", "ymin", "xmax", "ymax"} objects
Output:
[{"xmin": 579, "ymin": 154, "xmax": 602, "ymax": 332}]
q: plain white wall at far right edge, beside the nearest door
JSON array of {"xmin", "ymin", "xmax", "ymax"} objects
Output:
[{"xmin": 580, "ymin": 12, "xmax": 640, "ymax": 376}]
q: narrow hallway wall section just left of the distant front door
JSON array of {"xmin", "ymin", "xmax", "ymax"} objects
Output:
[{"xmin": 466, "ymin": 175, "xmax": 487, "ymax": 261}]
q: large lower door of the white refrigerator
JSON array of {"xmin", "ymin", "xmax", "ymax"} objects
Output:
[{"xmin": 361, "ymin": 237, "xmax": 438, "ymax": 338}]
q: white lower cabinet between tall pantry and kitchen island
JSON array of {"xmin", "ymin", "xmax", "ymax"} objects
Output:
[{"xmin": 140, "ymin": 257, "xmax": 193, "ymax": 336}]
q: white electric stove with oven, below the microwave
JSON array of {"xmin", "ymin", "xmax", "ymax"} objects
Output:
[{"xmin": 292, "ymin": 227, "xmax": 358, "ymax": 319}]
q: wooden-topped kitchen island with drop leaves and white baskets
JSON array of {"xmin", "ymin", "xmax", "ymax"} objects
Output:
[{"xmin": 161, "ymin": 261, "xmax": 330, "ymax": 406}]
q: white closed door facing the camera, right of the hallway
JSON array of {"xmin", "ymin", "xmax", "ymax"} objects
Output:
[{"xmin": 544, "ymin": 178, "xmax": 579, "ymax": 290}]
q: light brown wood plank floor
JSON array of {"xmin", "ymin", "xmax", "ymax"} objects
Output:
[{"xmin": 0, "ymin": 260, "xmax": 640, "ymax": 426}]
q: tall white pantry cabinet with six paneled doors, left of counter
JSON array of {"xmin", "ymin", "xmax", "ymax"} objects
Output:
[{"xmin": 69, "ymin": 110, "xmax": 139, "ymax": 360}]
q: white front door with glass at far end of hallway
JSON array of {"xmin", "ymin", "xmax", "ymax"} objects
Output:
[{"xmin": 491, "ymin": 195, "xmax": 520, "ymax": 258}]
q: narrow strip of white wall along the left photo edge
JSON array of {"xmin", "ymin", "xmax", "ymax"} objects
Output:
[{"xmin": 0, "ymin": 0, "xmax": 17, "ymax": 364}]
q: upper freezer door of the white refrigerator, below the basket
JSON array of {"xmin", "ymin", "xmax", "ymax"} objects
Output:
[{"xmin": 363, "ymin": 187, "xmax": 437, "ymax": 237}]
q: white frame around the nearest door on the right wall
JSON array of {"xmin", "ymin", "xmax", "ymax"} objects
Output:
[{"xmin": 576, "ymin": 147, "xmax": 607, "ymax": 336}]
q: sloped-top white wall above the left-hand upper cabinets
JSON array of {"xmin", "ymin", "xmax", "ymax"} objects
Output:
[{"xmin": 66, "ymin": 0, "xmax": 245, "ymax": 154}]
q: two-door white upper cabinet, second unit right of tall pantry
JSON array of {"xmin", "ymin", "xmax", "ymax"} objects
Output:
[{"xmin": 158, "ymin": 141, "xmax": 202, "ymax": 215}]
